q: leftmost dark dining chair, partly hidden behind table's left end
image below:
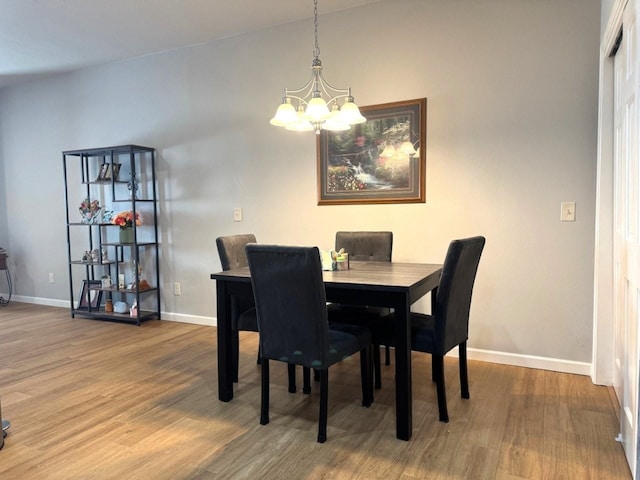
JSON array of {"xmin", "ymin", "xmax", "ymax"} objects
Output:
[{"xmin": 216, "ymin": 233, "xmax": 296, "ymax": 393}]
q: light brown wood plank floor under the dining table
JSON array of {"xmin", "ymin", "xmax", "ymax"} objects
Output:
[{"xmin": 0, "ymin": 303, "xmax": 631, "ymax": 480}]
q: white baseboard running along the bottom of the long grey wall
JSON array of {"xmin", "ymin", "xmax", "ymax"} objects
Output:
[{"xmin": 7, "ymin": 293, "xmax": 591, "ymax": 376}]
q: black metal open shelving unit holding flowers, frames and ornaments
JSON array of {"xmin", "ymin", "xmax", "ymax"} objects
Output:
[{"xmin": 62, "ymin": 145, "xmax": 160, "ymax": 325}]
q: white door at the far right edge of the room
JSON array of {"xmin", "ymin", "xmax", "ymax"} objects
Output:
[{"xmin": 613, "ymin": 0, "xmax": 640, "ymax": 478}]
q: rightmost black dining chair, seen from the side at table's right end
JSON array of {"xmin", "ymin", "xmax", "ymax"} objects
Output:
[{"xmin": 374, "ymin": 236, "xmax": 485, "ymax": 422}]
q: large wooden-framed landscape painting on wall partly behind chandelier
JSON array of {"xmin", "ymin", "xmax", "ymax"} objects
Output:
[{"xmin": 317, "ymin": 98, "xmax": 427, "ymax": 205}]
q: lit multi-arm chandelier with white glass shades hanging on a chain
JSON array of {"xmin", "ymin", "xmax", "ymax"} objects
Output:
[{"xmin": 269, "ymin": 0, "xmax": 367, "ymax": 134}]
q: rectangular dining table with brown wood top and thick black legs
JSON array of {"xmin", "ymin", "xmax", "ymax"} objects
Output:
[{"xmin": 211, "ymin": 262, "xmax": 442, "ymax": 440}]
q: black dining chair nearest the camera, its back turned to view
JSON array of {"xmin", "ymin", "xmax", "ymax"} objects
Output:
[{"xmin": 246, "ymin": 244, "xmax": 373, "ymax": 443}]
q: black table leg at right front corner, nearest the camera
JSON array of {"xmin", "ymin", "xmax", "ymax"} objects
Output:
[{"xmin": 394, "ymin": 297, "xmax": 413, "ymax": 440}]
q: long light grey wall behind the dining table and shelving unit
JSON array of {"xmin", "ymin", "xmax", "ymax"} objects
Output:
[{"xmin": 0, "ymin": 0, "xmax": 600, "ymax": 363}]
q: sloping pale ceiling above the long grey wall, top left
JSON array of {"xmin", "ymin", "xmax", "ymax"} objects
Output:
[{"xmin": 0, "ymin": 0, "xmax": 380, "ymax": 87}]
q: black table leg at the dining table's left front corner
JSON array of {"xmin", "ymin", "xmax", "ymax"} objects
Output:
[{"xmin": 216, "ymin": 280, "xmax": 233, "ymax": 402}]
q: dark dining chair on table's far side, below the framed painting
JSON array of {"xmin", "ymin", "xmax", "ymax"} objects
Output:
[{"xmin": 328, "ymin": 231, "xmax": 393, "ymax": 388}]
